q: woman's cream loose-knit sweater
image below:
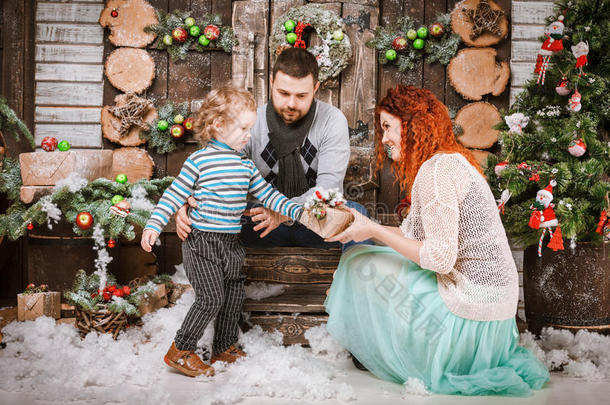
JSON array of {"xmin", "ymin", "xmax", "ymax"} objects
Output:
[{"xmin": 400, "ymin": 153, "xmax": 519, "ymax": 321}]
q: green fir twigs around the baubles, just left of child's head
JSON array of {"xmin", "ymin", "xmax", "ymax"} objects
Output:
[{"xmin": 140, "ymin": 101, "xmax": 189, "ymax": 155}]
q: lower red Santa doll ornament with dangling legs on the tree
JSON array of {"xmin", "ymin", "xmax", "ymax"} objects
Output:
[{"xmin": 528, "ymin": 180, "xmax": 563, "ymax": 256}]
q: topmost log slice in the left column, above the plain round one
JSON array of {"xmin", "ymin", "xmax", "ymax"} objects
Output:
[{"xmin": 99, "ymin": 0, "xmax": 159, "ymax": 48}]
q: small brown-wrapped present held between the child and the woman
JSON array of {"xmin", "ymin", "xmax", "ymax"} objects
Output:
[{"xmin": 299, "ymin": 190, "xmax": 354, "ymax": 238}]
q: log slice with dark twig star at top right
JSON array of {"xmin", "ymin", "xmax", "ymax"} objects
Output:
[{"xmin": 451, "ymin": 0, "xmax": 508, "ymax": 47}]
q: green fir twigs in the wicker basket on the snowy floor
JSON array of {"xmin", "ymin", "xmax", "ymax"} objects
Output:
[{"xmin": 64, "ymin": 270, "xmax": 154, "ymax": 317}]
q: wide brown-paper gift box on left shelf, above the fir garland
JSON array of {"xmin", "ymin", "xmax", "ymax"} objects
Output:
[{"xmin": 19, "ymin": 150, "xmax": 113, "ymax": 186}]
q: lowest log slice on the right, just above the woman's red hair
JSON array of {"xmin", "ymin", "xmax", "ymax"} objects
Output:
[{"xmin": 455, "ymin": 101, "xmax": 502, "ymax": 149}]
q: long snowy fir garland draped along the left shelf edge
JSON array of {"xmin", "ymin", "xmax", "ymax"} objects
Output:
[{"xmin": 0, "ymin": 159, "xmax": 173, "ymax": 240}]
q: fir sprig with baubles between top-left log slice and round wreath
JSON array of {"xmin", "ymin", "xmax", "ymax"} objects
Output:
[{"xmin": 144, "ymin": 9, "xmax": 237, "ymax": 60}]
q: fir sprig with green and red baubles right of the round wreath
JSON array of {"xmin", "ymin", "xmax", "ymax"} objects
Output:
[{"xmin": 366, "ymin": 14, "xmax": 461, "ymax": 72}]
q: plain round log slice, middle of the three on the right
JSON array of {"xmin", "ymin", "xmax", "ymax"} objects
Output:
[{"xmin": 447, "ymin": 48, "xmax": 510, "ymax": 101}]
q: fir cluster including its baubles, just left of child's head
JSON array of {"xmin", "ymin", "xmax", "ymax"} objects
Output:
[{"xmin": 141, "ymin": 101, "xmax": 193, "ymax": 154}]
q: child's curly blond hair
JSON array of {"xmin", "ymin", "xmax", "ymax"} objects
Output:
[{"xmin": 193, "ymin": 85, "xmax": 256, "ymax": 146}]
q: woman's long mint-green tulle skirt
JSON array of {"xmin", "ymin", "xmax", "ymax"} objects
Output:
[{"xmin": 325, "ymin": 245, "xmax": 549, "ymax": 396}]
